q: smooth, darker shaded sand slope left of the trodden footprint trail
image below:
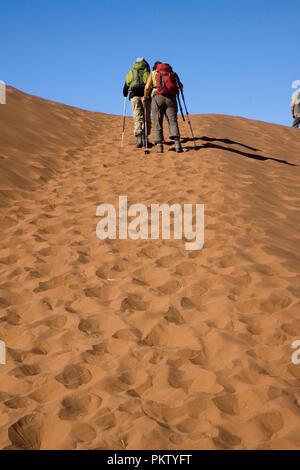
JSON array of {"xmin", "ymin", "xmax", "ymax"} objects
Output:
[{"xmin": 0, "ymin": 87, "xmax": 101, "ymax": 206}]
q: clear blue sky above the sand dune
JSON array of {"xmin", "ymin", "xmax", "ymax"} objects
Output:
[{"xmin": 0, "ymin": 0, "xmax": 300, "ymax": 125}]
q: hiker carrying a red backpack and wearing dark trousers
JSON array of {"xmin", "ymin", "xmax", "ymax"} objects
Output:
[{"xmin": 144, "ymin": 61, "xmax": 183, "ymax": 153}]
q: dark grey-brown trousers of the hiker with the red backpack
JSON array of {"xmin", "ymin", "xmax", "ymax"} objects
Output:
[{"xmin": 151, "ymin": 95, "xmax": 180, "ymax": 144}]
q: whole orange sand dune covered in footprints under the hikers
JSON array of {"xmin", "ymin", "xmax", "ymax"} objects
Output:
[{"xmin": 0, "ymin": 89, "xmax": 300, "ymax": 449}]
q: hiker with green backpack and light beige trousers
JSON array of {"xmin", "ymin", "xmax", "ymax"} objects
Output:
[{"xmin": 123, "ymin": 57, "xmax": 151, "ymax": 148}]
